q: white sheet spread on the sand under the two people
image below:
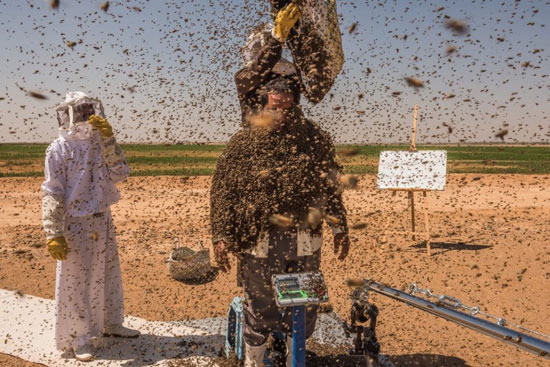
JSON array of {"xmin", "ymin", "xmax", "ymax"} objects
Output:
[{"xmin": 0, "ymin": 289, "xmax": 396, "ymax": 367}]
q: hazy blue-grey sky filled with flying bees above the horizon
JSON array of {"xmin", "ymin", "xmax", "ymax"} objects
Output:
[{"xmin": 0, "ymin": 0, "xmax": 550, "ymax": 143}]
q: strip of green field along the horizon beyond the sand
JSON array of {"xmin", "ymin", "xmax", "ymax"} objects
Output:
[{"xmin": 0, "ymin": 144, "xmax": 550, "ymax": 177}]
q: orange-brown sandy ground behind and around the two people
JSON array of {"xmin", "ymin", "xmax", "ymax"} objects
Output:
[{"xmin": 0, "ymin": 174, "xmax": 550, "ymax": 367}]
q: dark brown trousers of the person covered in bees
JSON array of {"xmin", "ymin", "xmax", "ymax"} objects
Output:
[{"xmin": 241, "ymin": 230, "xmax": 321, "ymax": 346}]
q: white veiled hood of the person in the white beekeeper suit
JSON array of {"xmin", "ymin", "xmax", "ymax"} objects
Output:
[{"xmin": 55, "ymin": 92, "xmax": 105, "ymax": 140}]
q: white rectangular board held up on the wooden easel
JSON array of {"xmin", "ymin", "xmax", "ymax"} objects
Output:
[{"xmin": 377, "ymin": 150, "xmax": 447, "ymax": 190}]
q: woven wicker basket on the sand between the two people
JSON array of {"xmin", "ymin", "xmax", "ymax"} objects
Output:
[{"xmin": 168, "ymin": 246, "xmax": 212, "ymax": 280}]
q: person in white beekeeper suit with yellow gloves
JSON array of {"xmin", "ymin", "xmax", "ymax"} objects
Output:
[{"xmin": 41, "ymin": 92, "xmax": 140, "ymax": 361}]
